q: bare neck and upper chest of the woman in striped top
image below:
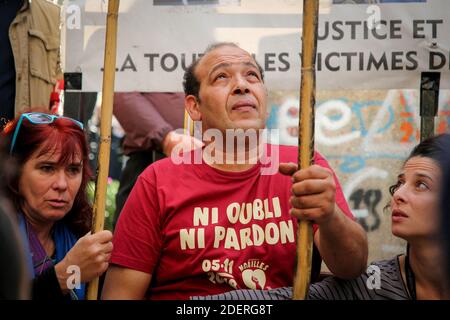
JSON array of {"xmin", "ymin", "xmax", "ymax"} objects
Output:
[{"xmin": 409, "ymin": 240, "xmax": 450, "ymax": 300}]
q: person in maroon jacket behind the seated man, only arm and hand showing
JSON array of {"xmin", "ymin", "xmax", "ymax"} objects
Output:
[{"xmin": 113, "ymin": 92, "xmax": 201, "ymax": 226}]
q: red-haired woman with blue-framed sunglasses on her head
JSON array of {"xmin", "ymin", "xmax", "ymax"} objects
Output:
[{"xmin": 2, "ymin": 112, "xmax": 112, "ymax": 299}]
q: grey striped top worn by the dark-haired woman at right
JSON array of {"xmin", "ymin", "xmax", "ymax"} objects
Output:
[{"xmin": 191, "ymin": 256, "xmax": 410, "ymax": 300}]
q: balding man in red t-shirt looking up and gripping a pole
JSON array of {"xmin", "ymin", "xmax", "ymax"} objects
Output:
[{"xmin": 103, "ymin": 43, "xmax": 367, "ymax": 299}]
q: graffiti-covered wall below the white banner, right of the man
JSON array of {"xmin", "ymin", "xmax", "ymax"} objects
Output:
[{"xmin": 269, "ymin": 90, "xmax": 450, "ymax": 257}]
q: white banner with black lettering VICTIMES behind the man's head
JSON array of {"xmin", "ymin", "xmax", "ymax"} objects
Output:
[{"xmin": 64, "ymin": 0, "xmax": 450, "ymax": 91}]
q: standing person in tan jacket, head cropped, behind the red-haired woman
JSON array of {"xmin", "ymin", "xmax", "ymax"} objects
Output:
[{"xmin": 0, "ymin": 0, "xmax": 63, "ymax": 129}]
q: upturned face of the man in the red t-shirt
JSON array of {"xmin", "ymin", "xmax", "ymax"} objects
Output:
[{"xmin": 188, "ymin": 46, "xmax": 267, "ymax": 132}]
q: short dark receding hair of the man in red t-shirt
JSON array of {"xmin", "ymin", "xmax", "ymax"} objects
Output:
[{"xmin": 183, "ymin": 42, "xmax": 264, "ymax": 100}]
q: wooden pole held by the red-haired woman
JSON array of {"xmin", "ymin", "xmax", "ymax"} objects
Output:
[{"xmin": 87, "ymin": 0, "xmax": 120, "ymax": 300}]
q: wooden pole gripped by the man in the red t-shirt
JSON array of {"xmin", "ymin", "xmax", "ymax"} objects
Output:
[{"xmin": 293, "ymin": 0, "xmax": 319, "ymax": 300}]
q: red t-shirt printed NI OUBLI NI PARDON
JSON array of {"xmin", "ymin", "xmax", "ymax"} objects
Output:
[{"xmin": 111, "ymin": 146, "xmax": 353, "ymax": 299}]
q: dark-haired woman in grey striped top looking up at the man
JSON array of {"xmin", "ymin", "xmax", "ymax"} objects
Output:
[{"xmin": 193, "ymin": 134, "xmax": 450, "ymax": 300}]
